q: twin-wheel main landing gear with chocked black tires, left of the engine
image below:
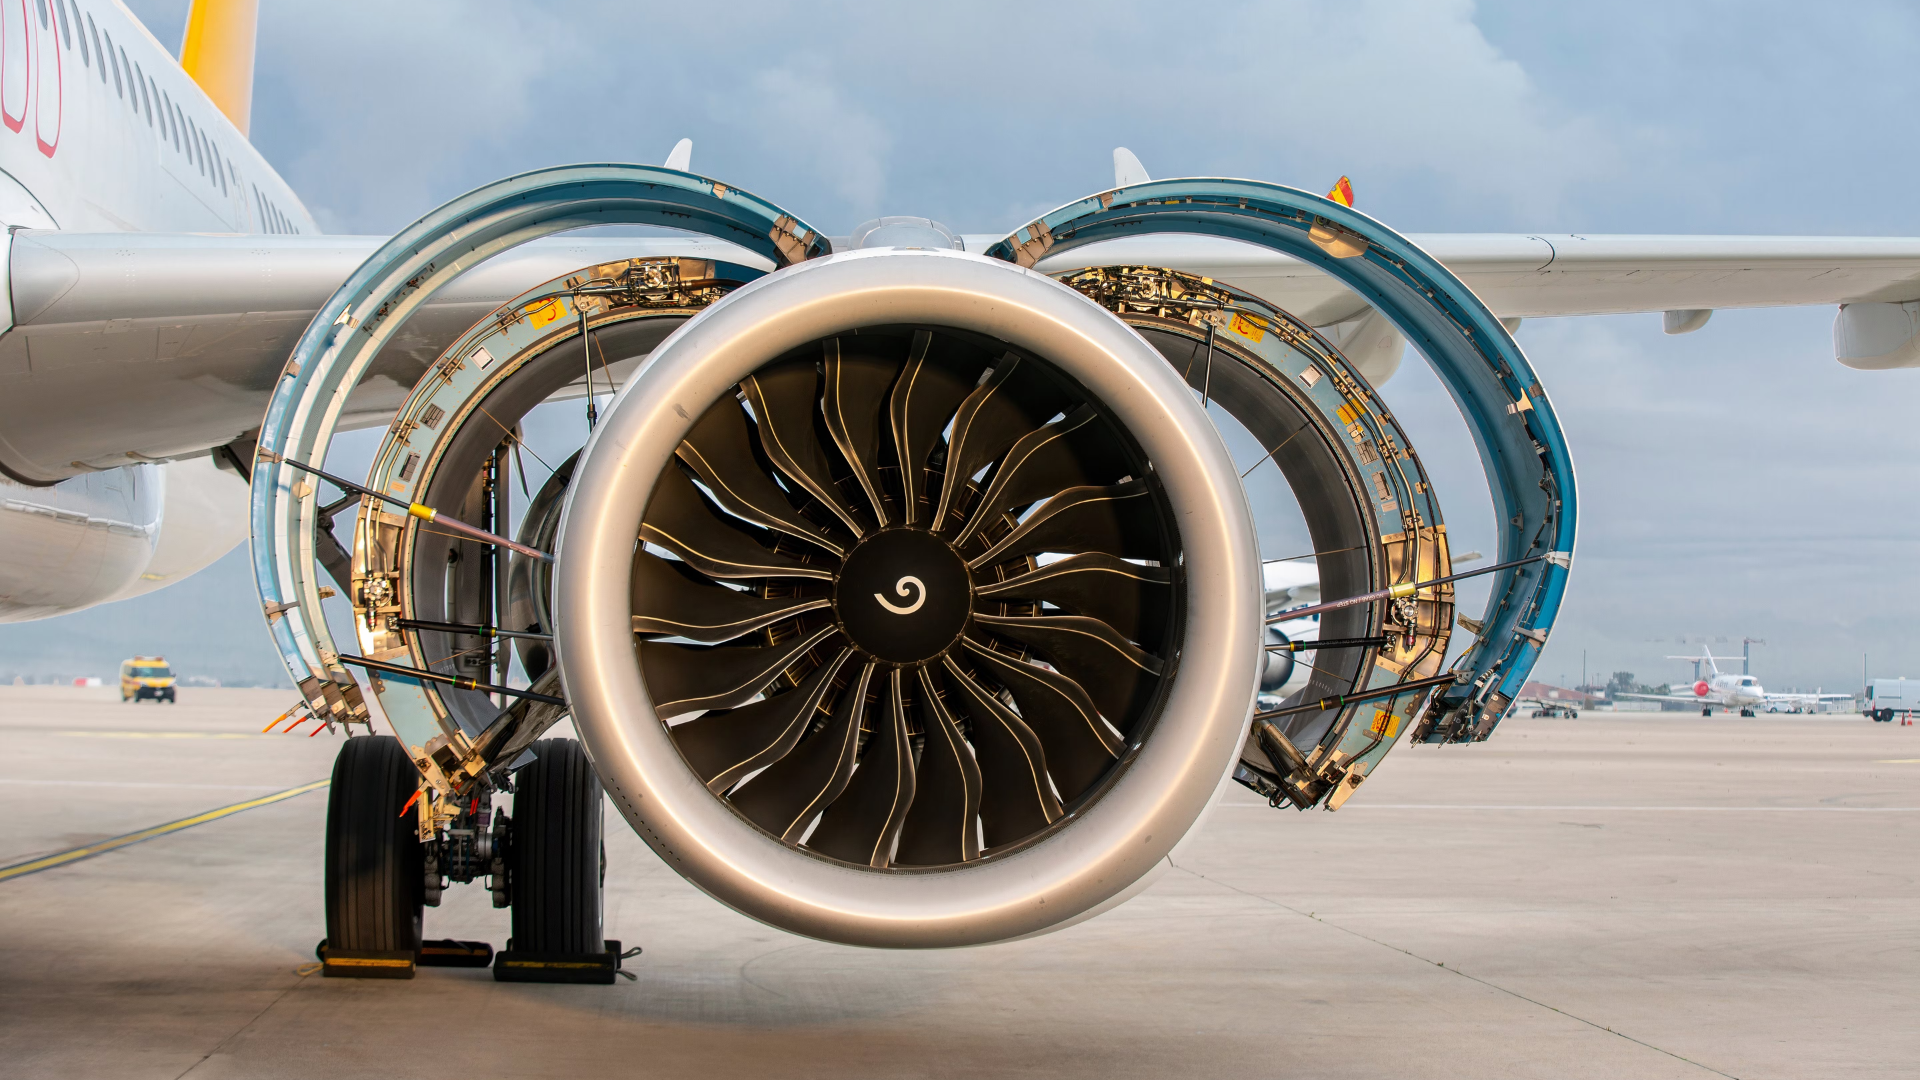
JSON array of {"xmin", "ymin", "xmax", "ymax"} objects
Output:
[{"xmin": 317, "ymin": 736, "xmax": 637, "ymax": 984}]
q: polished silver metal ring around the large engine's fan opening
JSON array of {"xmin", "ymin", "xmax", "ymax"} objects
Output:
[{"xmin": 555, "ymin": 250, "xmax": 1263, "ymax": 947}]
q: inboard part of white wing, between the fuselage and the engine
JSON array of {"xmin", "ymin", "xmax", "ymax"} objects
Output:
[{"xmin": 0, "ymin": 231, "xmax": 770, "ymax": 482}]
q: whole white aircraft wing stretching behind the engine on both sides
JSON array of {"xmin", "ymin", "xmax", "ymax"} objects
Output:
[{"xmin": 11, "ymin": 231, "xmax": 1920, "ymax": 482}]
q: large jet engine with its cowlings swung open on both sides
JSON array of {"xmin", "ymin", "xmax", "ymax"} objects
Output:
[{"xmin": 253, "ymin": 159, "xmax": 1571, "ymax": 947}]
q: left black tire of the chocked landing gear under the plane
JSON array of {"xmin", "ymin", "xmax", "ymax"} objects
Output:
[{"xmin": 326, "ymin": 736, "xmax": 426, "ymax": 953}]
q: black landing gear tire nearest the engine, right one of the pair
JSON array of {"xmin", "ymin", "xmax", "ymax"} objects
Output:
[{"xmin": 507, "ymin": 738, "xmax": 607, "ymax": 955}]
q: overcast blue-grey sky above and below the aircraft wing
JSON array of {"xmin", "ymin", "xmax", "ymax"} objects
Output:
[{"xmin": 0, "ymin": 0, "xmax": 1920, "ymax": 690}]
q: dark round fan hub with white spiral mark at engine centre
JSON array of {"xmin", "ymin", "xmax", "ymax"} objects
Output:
[{"xmin": 833, "ymin": 528, "xmax": 973, "ymax": 665}]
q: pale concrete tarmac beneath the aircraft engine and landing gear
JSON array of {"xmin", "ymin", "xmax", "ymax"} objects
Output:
[{"xmin": 0, "ymin": 688, "xmax": 1920, "ymax": 1080}]
